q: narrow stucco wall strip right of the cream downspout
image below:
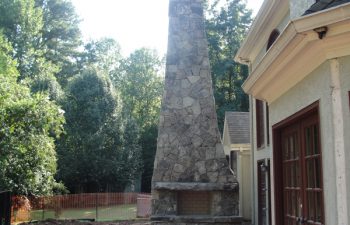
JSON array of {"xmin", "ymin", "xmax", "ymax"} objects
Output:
[{"xmin": 339, "ymin": 56, "xmax": 350, "ymax": 221}]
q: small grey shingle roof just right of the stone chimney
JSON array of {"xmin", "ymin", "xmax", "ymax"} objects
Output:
[{"xmin": 225, "ymin": 112, "xmax": 250, "ymax": 144}]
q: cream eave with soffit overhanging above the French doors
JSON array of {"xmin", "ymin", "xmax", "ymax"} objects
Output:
[{"xmin": 243, "ymin": 4, "xmax": 350, "ymax": 103}]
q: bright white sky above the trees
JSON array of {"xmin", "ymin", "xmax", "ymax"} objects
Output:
[{"xmin": 72, "ymin": 0, "xmax": 263, "ymax": 56}]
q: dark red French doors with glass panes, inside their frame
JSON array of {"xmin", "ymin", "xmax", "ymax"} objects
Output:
[{"xmin": 280, "ymin": 114, "xmax": 324, "ymax": 225}]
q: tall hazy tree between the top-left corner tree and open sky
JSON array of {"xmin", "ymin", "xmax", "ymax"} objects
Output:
[{"xmin": 35, "ymin": 0, "xmax": 82, "ymax": 85}]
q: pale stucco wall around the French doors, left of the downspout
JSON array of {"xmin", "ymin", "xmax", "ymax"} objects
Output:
[{"xmin": 270, "ymin": 62, "xmax": 337, "ymax": 224}]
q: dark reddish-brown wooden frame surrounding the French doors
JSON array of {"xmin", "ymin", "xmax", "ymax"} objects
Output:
[{"xmin": 272, "ymin": 101, "xmax": 323, "ymax": 225}]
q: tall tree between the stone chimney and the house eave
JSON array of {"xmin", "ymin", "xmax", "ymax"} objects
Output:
[{"xmin": 206, "ymin": 0, "xmax": 252, "ymax": 130}]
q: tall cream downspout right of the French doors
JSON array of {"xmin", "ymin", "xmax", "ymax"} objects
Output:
[{"xmin": 330, "ymin": 59, "xmax": 349, "ymax": 225}]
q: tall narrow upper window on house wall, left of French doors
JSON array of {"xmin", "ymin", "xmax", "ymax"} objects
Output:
[{"xmin": 255, "ymin": 99, "xmax": 265, "ymax": 148}]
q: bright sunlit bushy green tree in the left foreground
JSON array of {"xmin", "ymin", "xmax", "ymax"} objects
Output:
[{"xmin": 0, "ymin": 35, "xmax": 64, "ymax": 195}]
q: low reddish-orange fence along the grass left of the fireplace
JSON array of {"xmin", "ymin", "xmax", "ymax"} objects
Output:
[{"xmin": 12, "ymin": 193, "xmax": 151, "ymax": 222}]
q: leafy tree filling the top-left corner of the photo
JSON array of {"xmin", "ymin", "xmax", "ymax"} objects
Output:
[{"xmin": 0, "ymin": 0, "xmax": 45, "ymax": 79}]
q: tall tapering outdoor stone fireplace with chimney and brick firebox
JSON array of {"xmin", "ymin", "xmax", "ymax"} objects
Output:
[{"xmin": 151, "ymin": 0, "xmax": 241, "ymax": 225}]
